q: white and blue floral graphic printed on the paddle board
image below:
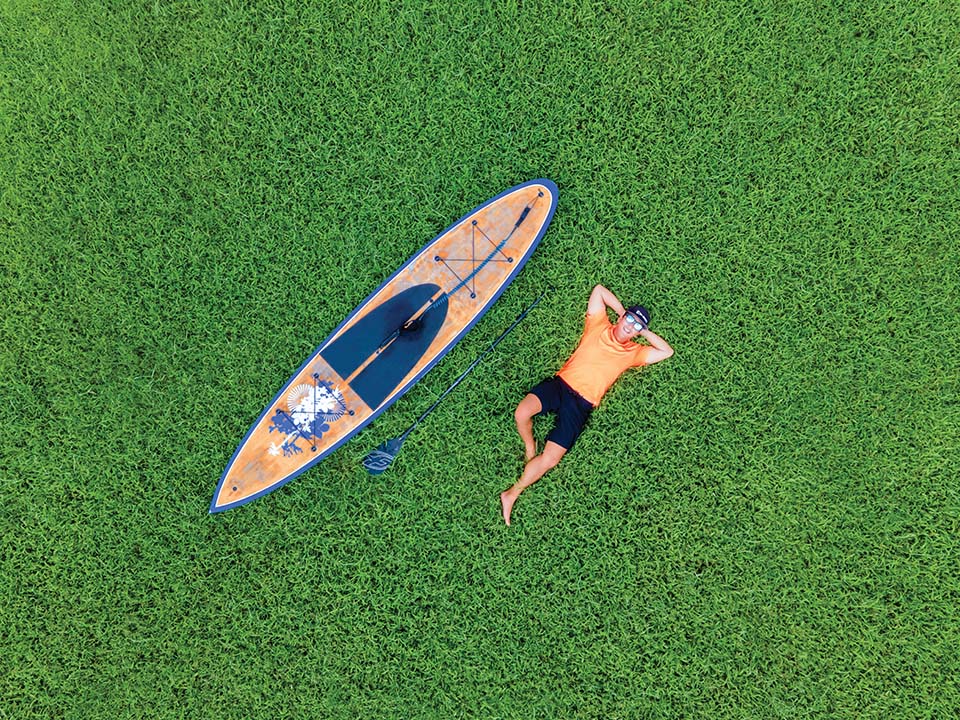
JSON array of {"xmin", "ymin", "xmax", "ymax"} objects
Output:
[{"xmin": 267, "ymin": 380, "xmax": 347, "ymax": 457}]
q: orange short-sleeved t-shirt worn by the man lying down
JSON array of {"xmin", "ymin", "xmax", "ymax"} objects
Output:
[{"xmin": 557, "ymin": 312, "xmax": 653, "ymax": 407}]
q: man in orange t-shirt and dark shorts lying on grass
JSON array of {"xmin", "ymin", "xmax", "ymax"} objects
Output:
[{"xmin": 500, "ymin": 285, "xmax": 673, "ymax": 525}]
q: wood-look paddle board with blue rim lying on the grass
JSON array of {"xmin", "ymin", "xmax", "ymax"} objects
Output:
[{"xmin": 210, "ymin": 179, "xmax": 558, "ymax": 513}]
